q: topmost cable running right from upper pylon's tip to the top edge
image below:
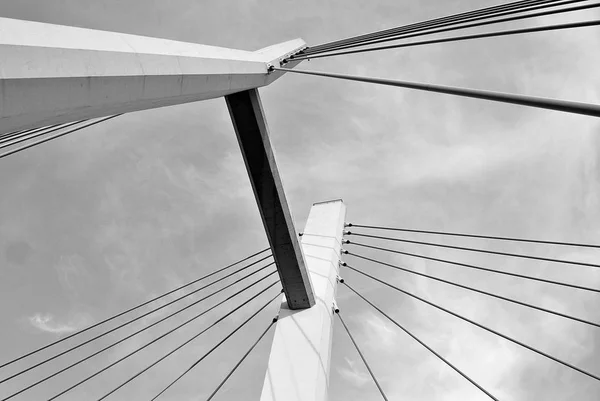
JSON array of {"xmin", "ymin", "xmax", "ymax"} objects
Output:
[{"xmin": 309, "ymin": 0, "xmax": 559, "ymax": 52}]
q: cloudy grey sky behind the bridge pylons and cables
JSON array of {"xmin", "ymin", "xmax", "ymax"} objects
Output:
[{"xmin": 0, "ymin": 0, "xmax": 600, "ymax": 401}]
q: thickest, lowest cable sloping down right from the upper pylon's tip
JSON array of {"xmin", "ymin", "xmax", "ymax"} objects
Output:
[{"xmin": 272, "ymin": 67, "xmax": 600, "ymax": 117}]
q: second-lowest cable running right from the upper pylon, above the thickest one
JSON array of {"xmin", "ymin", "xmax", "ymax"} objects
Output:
[{"xmin": 293, "ymin": 17, "xmax": 600, "ymax": 61}]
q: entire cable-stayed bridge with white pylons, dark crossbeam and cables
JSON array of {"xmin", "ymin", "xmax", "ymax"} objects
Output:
[{"xmin": 0, "ymin": 1, "xmax": 600, "ymax": 400}]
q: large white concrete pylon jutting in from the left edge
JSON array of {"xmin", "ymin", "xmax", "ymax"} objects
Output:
[{"xmin": 0, "ymin": 18, "xmax": 306, "ymax": 133}]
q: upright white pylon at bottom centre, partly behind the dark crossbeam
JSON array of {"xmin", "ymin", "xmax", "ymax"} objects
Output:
[{"xmin": 261, "ymin": 200, "xmax": 346, "ymax": 401}]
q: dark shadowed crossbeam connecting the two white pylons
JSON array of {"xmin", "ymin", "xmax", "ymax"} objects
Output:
[{"xmin": 225, "ymin": 89, "xmax": 315, "ymax": 309}]
